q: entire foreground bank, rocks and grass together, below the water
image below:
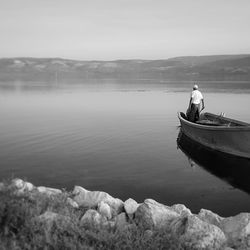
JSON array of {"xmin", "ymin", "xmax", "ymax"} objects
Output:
[{"xmin": 0, "ymin": 179, "xmax": 250, "ymax": 250}]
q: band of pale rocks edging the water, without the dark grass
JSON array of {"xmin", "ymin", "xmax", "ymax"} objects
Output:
[{"xmin": 0, "ymin": 179, "xmax": 250, "ymax": 250}]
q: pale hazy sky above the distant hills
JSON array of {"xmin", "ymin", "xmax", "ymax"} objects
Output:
[{"xmin": 0, "ymin": 0, "xmax": 250, "ymax": 60}]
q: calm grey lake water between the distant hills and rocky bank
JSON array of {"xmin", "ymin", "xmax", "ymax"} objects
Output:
[{"xmin": 0, "ymin": 80, "xmax": 250, "ymax": 216}]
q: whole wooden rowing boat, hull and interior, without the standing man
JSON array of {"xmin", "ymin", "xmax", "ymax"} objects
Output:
[{"xmin": 178, "ymin": 112, "xmax": 250, "ymax": 158}]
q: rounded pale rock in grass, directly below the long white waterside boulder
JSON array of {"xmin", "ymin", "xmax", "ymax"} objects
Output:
[{"xmin": 80, "ymin": 209, "xmax": 107, "ymax": 228}]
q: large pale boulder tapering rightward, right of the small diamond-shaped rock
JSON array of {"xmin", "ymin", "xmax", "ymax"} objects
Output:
[{"xmin": 135, "ymin": 199, "xmax": 180, "ymax": 229}]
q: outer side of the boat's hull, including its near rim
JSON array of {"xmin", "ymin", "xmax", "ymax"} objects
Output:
[{"xmin": 178, "ymin": 113, "xmax": 250, "ymax": 158}]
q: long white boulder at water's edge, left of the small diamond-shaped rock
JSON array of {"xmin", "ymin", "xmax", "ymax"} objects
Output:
[{"xmin": 73, "ymin": 186, "xmax": 123, "ymax": 214}]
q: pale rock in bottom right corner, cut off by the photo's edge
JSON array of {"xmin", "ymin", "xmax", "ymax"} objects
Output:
[{"xmin": 221, "ymin": 213, "xmax": 250, "ymax": 249}]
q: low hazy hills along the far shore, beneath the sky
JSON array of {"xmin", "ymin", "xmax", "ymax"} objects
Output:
[{"xmin": 0, "ymin": 54, "xmax": 250, "ymax": 82}]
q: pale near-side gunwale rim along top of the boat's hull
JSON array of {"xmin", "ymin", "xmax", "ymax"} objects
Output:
[{"xmin": 178, "ymin": 112, "xmax": 250, "ymax": 132}]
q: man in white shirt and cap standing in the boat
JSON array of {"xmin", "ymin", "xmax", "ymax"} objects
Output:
[{"xmin": 187, "ymin": 84, "xmax": 205, "ymax": 122}]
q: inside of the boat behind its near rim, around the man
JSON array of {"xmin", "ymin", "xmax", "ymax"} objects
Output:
[{"xmin": 181, "ymin": 112, "xmax": 250, "ymax": 127}]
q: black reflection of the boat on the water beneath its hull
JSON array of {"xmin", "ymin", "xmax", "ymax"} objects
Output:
[{"xmin": 177, "ymin": 130, "xmax": 250, "ymax": 194}]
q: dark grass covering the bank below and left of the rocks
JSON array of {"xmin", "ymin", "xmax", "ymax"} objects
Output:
[{"xmin": 0, "ymin": 182, "xmax": 182, "ymax": 250}]
